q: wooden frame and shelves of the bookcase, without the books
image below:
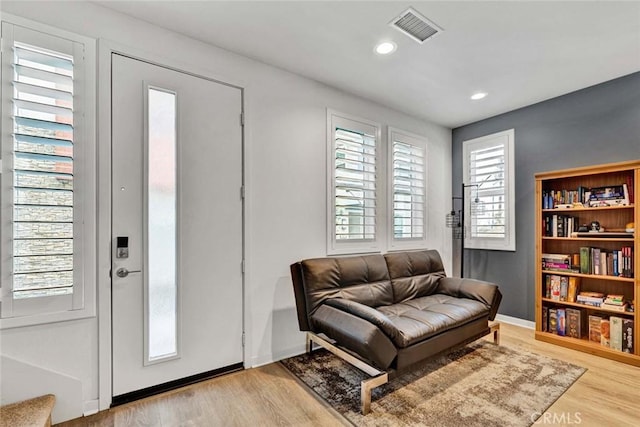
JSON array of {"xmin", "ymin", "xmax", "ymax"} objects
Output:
[{"xmin": 535, "ymin": 160, "xmax": 640, "ymax": 366}]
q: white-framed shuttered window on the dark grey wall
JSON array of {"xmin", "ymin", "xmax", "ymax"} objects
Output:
[{"xmin": 463, "ymin": 130, "xmax": 515, "ymax": 250}]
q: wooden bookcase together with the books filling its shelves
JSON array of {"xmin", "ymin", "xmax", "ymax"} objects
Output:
[{"xmin": 535, "ymin": 160, "xmax": 640, "ymax": 367}]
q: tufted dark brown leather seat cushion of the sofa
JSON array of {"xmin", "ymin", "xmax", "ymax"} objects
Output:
[{"xmin": 377, "ymin": 294, "xmax": 489, "ymax": 348}]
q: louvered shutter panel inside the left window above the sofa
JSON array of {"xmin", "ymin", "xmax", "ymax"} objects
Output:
[{"xmin": 334, "ymin": 127, "xmax": 376, "ymax": 241}]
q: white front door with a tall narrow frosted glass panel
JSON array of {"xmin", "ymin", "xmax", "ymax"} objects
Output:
[{"xmin": 111, "ymin": 54, "xmax": 243, "ymax": 402}]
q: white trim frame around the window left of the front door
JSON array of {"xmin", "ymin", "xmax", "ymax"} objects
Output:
[{"xmin": 0, "ymin": 14, "xmax": 97, "ymax": 329}]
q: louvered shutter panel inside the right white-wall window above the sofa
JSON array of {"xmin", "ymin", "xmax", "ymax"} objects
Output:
[{"xmin": 392, "ymin": 140, "xmax": 426, "ymax": 239}]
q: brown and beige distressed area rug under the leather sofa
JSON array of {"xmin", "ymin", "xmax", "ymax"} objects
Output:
[{"xmin": 281, "ymin": 340, "xmax": 586, "ymax": 427}]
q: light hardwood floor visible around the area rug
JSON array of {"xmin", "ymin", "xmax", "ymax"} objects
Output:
[{"xmin": 59, "ymin": 323, "xmax": 640, "ymax": 427}]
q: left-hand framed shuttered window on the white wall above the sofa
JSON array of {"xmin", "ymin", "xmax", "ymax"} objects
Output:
[{"xmin": 328, "ymin": 113, "xmax": 380, "ymax": 253}]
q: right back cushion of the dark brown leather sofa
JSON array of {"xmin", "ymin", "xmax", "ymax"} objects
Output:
[{"xmin": 379, "ymin": 250, "xmax": 445, "ymax": 305}]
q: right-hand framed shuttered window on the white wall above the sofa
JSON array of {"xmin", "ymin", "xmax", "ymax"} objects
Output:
[{"xmin": 389, "ymin": 128, "xmax": 427, "ymax": 248}]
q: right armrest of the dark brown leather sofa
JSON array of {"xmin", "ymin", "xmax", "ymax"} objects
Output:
[{"xmin": 436, "ymin": 277, "xmax": 502, "ymax": 320}]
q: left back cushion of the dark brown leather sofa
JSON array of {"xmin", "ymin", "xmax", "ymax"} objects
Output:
[{"xmin": 300, "ymin": 255, "xmax": 393, "ymax": 315}]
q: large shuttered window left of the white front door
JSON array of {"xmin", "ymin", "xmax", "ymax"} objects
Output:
[{"xmin": 1, "ymin": 22, "xmax": 91, "ymax": 325}]
